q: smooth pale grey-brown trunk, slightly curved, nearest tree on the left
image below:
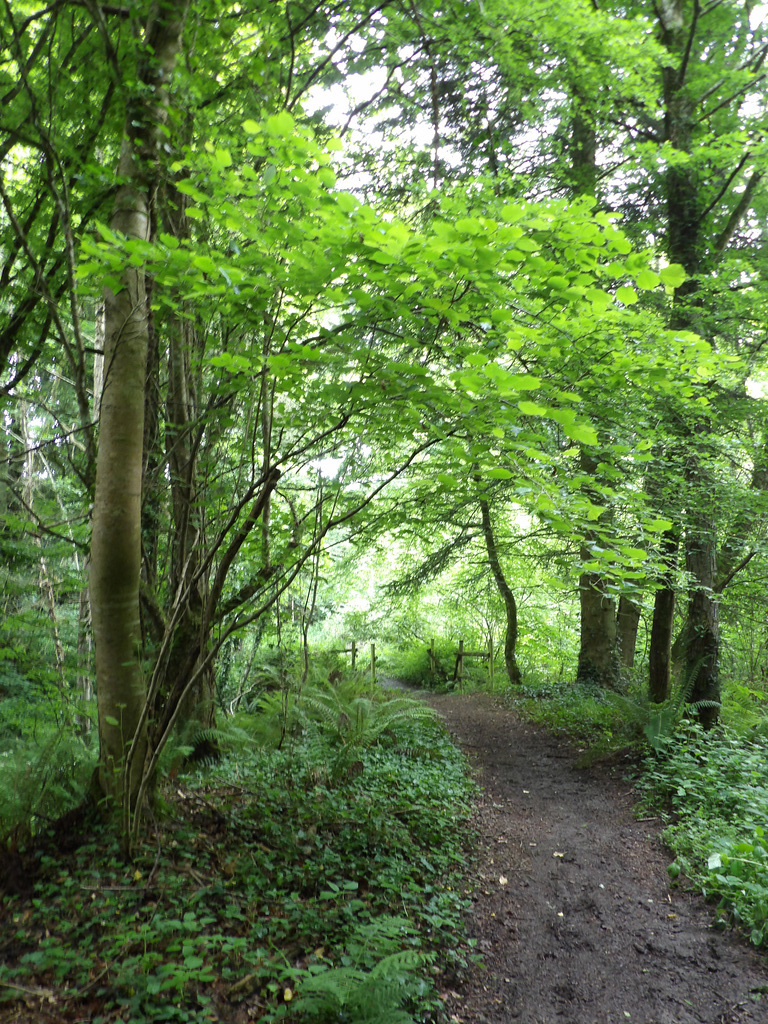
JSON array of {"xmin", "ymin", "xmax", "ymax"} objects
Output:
[{"xmin": 90, "ymin": 0, "xmax": 189, "ymax": 803}]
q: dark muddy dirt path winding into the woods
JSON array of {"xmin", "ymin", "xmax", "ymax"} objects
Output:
[{"xmin": 421, "ymin": 693, "xmax": 768, "ymax": 1024}]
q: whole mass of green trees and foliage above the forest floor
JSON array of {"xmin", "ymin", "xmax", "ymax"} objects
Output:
[{"xmin": 0, "ymin": 0, "xmax": 768, "ymax": 1019}]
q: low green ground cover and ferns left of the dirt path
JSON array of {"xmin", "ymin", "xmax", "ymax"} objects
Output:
[{"xmin": 0, "ymin": 685, "xmax": 473, "ymax": 1024}]
